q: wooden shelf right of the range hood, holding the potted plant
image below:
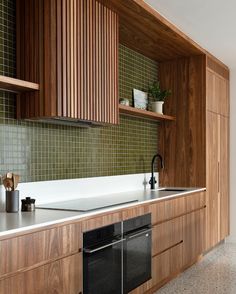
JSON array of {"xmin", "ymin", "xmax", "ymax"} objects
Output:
[{"xmin": 119, "ymin": 104, "xmax": 175, "ymax": 121}]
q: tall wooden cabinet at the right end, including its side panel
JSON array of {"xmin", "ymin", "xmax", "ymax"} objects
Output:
[{"xmin": 159, "ymin": 55, "xmax": 229, "ymax": 253}]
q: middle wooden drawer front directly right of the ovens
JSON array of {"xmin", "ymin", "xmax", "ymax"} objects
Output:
[{"xmin": 152, "ymin": 217, "xmax": 183, "ymax": 256}]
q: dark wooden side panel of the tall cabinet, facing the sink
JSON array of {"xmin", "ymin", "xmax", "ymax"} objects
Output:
[{"xmin": 159, "ymin": 56, "xmax": 206, "ymax": 187}]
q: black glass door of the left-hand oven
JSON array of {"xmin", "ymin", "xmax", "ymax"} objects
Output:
[{"xmin": 83, "ymin": 240, "xmax": 122, "ymax": 294}]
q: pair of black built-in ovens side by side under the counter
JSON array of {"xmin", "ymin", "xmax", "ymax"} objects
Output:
[{"xmin": 83, "ymin": 214, "xmax": 152, "ymax": 294}]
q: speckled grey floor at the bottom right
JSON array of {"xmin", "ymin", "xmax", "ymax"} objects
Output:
[{"xmin": 155, "ymin": 243, "xmax": 236, "ymax": 294}]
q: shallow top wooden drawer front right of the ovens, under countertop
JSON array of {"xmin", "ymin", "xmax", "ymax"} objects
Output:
[{"xmin": 150, "ymin": 197, "xmax": 185, "ymax": 225}]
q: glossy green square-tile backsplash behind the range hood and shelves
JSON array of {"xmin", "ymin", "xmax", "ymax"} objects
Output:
[{"xmin": 0, "ymin": 0, "xmax": 158, "ymax": 182}]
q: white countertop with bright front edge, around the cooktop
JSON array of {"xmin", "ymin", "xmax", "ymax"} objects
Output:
[{"xmin": 0, "ymin": 188, "xmax": 206, "ymax": 237}]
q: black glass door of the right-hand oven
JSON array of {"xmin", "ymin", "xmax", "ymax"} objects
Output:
[{"xmin": 124, "ymin": 229, "xmax": 152, "ymax": 294}]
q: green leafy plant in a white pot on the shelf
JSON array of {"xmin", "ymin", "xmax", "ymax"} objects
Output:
[{"xmin": 148, "ymin": 81, "xmax": 171, "ymax": 114}]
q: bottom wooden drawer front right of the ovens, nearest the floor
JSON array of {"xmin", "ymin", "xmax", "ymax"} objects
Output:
[{"xmin": 151, "ymin": 243, "xmax": 183, "ymax": 287}]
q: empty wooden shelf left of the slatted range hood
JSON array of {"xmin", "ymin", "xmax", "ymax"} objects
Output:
[{"xmin": 0, "ymin": 75, "xmax": 39, "ymax": 93}]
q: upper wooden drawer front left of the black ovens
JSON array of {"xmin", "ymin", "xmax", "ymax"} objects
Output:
[{"xmin": 0, "ymin": 224, "xmax": 80, "ymax": 277}]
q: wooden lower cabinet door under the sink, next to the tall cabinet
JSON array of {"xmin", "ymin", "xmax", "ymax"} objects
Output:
[{"xmin": 183, "ymin": 208, "xmax": 206, "ymax": 266}]
